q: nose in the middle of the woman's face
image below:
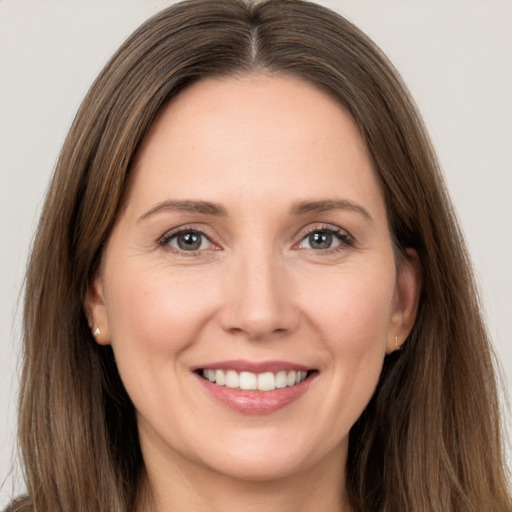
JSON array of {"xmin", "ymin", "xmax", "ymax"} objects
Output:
[{"xmin": 221, "ymin": 248, "xmax": 300, "ymax": 340}]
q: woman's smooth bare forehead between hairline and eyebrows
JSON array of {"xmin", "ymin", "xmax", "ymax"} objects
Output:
[{"xmin": 129, "ymin": 70, "xmax": 381, "ymax": 218}]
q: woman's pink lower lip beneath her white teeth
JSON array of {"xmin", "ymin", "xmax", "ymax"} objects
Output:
[{"xmin": 197, "ymin": 374, "xmax": 316, "ymax": 415}]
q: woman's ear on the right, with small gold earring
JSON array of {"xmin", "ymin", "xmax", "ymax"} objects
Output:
[{"xmin": 386, "ymin": 249, "xmax": 421, "ymax": 354}]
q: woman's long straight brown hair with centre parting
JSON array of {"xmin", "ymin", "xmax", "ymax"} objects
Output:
[{"xmin": 9, "ymin": 0, "xmax": 512, "ymax": 512}]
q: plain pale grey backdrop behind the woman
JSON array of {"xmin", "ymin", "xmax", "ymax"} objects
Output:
[{"xmin": 0, "ymin": 0, "xmax": 512, "ymax": 508}]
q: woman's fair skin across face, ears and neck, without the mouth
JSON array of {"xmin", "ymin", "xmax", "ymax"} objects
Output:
[{"xmin": 86, "ymin": 73, "xmax": 420, "ymax": 511}]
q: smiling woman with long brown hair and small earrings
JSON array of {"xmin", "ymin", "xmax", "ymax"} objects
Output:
[{"xmin": 5, "ymin": 0, "xmax": 511, "ymax": 511}]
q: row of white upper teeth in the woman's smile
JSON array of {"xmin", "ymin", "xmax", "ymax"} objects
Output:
[{"xmin": 202, "ymin": 370, "xmax": 308, "ymax": 391}]
